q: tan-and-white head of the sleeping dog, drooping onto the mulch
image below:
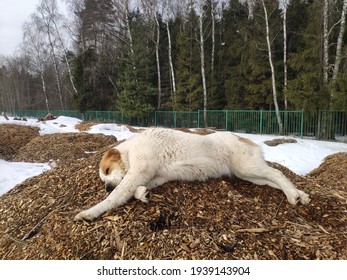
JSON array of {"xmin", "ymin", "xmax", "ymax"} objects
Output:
[{"xmin": 99, "ymin": 149, "xmax": 126, "ymax": 192}]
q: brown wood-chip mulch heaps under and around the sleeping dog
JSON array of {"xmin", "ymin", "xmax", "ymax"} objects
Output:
[{"xmin": 0, "ymin": 123, "xmax": 347, "ymax": 259}]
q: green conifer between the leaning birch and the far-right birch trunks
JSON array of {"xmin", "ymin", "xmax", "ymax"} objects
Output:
[{"xmin": 287, "ymin": 0, "xmax": 329, "ymax": 112}]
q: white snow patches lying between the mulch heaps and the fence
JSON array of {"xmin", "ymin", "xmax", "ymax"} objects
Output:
[{"xmin": 0, "ymin": 116, "xmax": 347, "ymax": 195}]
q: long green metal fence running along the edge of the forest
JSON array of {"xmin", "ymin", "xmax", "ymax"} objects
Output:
[{"xmin": 4, "ymin": 110, "xmax": 347, "ymax": 141}]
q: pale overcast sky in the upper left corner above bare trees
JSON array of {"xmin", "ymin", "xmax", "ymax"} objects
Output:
[{"xmin": 0, "ymin": 0, "xmax": 68, "ymax": 55}]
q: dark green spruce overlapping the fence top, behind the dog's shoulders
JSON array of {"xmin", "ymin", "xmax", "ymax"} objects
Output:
[{"xmin": 116, "ymin": 11, "xmax": 157, "ymax": 118}]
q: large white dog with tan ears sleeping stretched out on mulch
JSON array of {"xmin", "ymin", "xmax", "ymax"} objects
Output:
[{"xmin": 75, "ymin": 128, "xmax": 310, "ymax": 220}]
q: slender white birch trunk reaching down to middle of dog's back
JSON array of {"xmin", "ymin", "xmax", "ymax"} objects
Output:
[{"xmin": 199, "ymin": 0, "xmax": 207, "ymax": 127}]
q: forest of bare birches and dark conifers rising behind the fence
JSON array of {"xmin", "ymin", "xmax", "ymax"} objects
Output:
[{"xmin": 0, "ymin": 0, "xmax": 347, "ymax": 121}]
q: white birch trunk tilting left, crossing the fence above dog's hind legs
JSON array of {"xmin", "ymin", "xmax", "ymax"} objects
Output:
[{"xmin": 261, "ymin": 0, "xmax": 283, "ymax": 134}]
